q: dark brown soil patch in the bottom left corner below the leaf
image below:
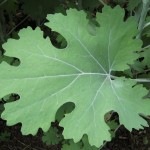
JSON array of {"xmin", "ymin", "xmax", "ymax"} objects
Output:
[{"xmin": 0, "ymin": 119, "xmax": 61, "ymax": 150}]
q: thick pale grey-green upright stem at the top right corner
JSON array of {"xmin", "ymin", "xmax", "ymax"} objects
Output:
[{"xmin": 137, "ymin": 0, "xmax": 150, "ymax": 39}]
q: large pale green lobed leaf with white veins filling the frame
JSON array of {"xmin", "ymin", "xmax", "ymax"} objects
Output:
[{"xmin": 0, "ymin": 6, "xmax": 150, "ymax": 147}]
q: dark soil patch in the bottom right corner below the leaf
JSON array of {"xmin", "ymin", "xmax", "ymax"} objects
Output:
[{"xmin": 102, "ymin": 126, "xmax": 150, "ymax": 150}]
